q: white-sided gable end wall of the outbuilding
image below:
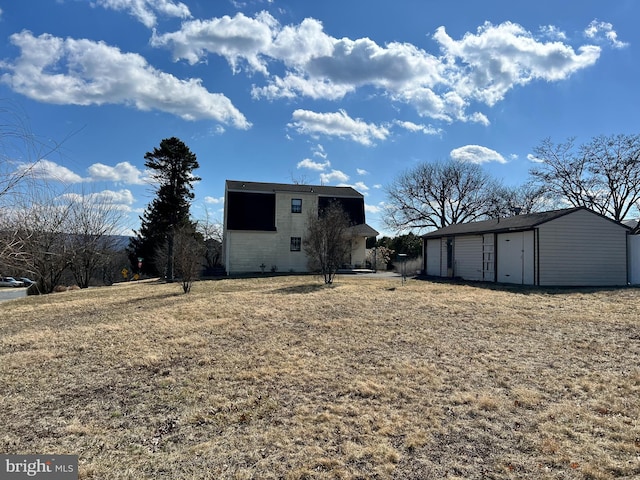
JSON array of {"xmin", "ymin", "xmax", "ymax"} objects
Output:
[{"xmin": 538, "ymin": 210, "xmax": 627, "ymax": 286}]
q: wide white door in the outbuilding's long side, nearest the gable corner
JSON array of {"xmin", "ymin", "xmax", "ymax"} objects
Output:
[{"xmin": 496, "ymin": 230, "xmax": 535, "ymax": 285}]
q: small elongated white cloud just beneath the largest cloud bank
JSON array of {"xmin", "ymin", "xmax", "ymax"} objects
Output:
[{"xmin": 289, "ymin": 110, "xmax": 389, "ymax": 146}]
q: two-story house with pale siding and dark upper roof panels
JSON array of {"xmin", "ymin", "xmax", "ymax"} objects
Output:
[{"xmin": 222, "ymin": 180, "xmax": 378, "ymax": 274}]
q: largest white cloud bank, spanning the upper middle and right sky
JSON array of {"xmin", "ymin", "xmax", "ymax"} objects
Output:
[{"xmin": 152, "ymin": 12, "xmax": 608, "ymax": 124}]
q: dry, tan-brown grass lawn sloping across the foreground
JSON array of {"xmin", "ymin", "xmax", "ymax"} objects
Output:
[{"xmin": 0, "ymin": 276, "xmax": 640, "ymax": 479}]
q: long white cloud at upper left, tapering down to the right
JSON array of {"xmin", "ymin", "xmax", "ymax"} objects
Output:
[{"xmin": 0, "ymin": 31, "xmax": 251, "ymax": 129}]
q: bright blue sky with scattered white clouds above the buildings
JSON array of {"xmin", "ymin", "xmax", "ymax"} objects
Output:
[{"xmin": 0, "ymin": 0, "xmax": 640, "ymax": 233}]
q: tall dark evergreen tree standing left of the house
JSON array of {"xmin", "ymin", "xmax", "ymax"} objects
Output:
[{"xmin": 128, "ymin": 137, "xmax": 200, "ymax": 281}]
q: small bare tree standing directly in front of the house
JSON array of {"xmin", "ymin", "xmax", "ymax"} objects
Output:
[{"xmin": 303, "ymin": 202, "xmax": 351, "ymax": 284}]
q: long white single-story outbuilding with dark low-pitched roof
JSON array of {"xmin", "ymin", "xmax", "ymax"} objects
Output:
[{"xmin": 423, "ymin": 207, "xmax": 640, "ymax": 286}]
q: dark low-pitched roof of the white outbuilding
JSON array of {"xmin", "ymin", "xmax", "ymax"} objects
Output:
[{"xmin": 422, "ymin": 207, "xmax": 629, "ymax": 238}]
